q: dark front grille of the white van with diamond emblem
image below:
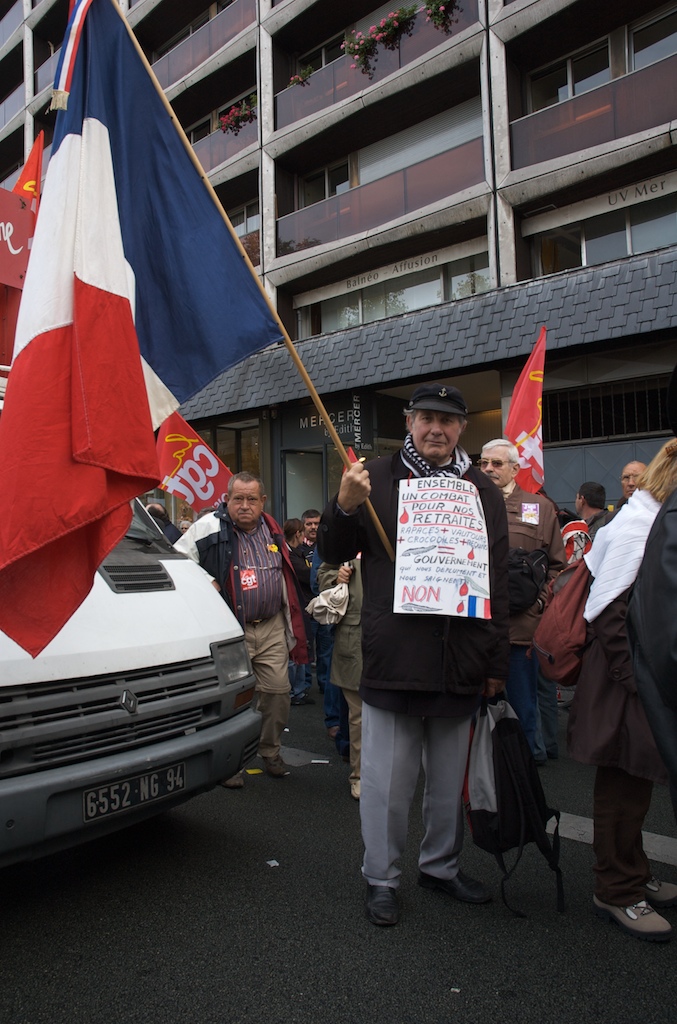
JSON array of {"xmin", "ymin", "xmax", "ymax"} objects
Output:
[{"xmin": 0, "ymin": 657, "xmax": 228, "ymax": 779}]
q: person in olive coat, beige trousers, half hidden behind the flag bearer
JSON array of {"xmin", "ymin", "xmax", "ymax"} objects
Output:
[{"xmin": 318, "ymin": 558, "xmax": 363, "ymax": 800}]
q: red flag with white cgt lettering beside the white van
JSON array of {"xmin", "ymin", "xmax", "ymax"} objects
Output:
[{"xmin": 158, "ymin": 413, "xmax": 232, "ymax": 512}]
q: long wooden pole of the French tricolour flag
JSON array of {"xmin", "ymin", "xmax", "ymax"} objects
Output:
[{"xmin": 111, "ymin": 0, "xmax": 395, "ymax": 561}]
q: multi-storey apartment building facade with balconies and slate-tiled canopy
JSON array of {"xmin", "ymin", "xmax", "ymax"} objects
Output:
[{"xmin": 0, "ymin": 0, "xmax": 677, "ymax": 517}]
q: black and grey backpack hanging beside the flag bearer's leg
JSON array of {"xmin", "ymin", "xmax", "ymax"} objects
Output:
[{"xmin": 464, "ymin": 700, "xmax": 564, "ymax": 918}]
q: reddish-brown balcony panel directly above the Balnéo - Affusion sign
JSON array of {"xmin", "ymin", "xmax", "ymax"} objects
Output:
[{"xmin": 278, "ymin": 138, "xmax": 484, "ymax": 256}]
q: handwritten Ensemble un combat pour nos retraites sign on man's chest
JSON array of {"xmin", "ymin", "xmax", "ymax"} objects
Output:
[{"xmin": 392, "ymin": 476, "xmax": 492, "ymax": 618}]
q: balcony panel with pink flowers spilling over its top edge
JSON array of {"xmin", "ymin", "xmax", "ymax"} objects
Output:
[{"xmin": 276, "ymin": 0, "xmax": 477, "ymax": 129}]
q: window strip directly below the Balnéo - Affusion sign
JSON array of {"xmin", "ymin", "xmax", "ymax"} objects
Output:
[{"xmin": 299, "ymin": 252, "xmax": 491, "ymax": 338}]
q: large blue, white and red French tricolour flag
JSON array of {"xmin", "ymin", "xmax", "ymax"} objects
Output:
[{"xmin": 0, "ymin": 0, "xmax": 282, "ymax": 656}]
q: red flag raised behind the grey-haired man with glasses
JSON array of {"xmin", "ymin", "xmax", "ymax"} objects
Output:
[{"xmin": 505, "ymin": 327, "xmax": 546, "ymax": 494}]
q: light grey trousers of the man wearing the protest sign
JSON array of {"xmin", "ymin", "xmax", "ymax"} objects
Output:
[{"xmin": 359, "ymin": 703, "xmax": 470, "ymax": 889}]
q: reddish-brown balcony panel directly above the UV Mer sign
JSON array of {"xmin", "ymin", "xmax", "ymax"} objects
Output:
[{"xmin": 510, "ymin": 54, "xmax": 677, "ymax": 169}]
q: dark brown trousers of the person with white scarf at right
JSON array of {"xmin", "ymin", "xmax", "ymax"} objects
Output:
[{"xmin": 592, "ymin": 767, "xmax": 653, "ymax": 906}]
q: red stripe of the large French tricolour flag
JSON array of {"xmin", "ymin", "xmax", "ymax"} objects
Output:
[{"xmin": 0, "ymin": 281, "xmax": 159, "ymax": 656}]
